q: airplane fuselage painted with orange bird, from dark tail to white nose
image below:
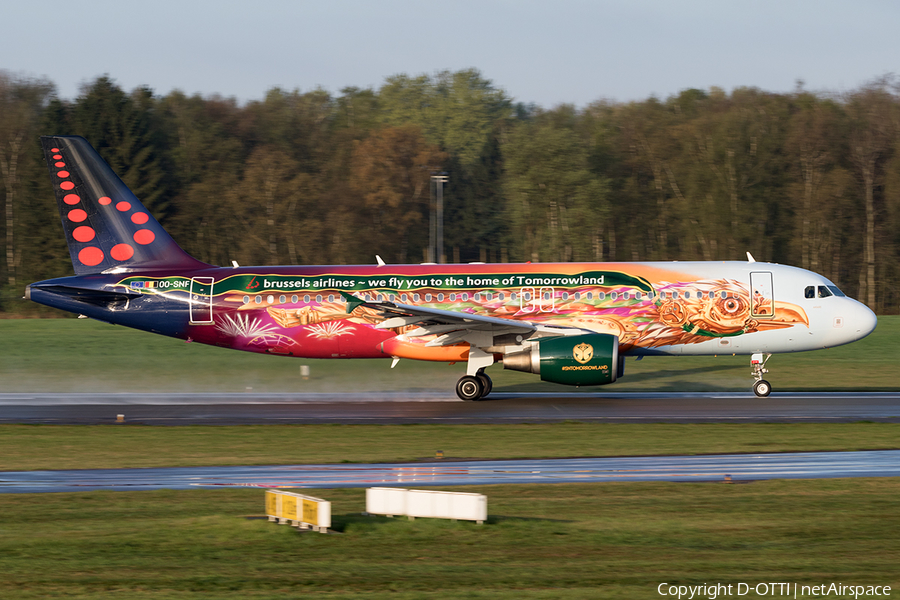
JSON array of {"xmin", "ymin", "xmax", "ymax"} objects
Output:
[{"xmin": 28, "ymin": 262, "xmax": 874, "ymax": 361}]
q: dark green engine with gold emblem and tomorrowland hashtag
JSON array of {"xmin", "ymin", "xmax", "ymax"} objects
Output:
[{"xmin": 503, "ymin": 333, "xmax": 622, "ymax": 385}]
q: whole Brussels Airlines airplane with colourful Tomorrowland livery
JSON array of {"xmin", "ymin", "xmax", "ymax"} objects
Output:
[{"xmin": 25, "ymin": 136, "xmax": 877, "ymax": 401}]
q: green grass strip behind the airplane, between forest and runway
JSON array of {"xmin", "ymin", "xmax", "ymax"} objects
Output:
[{"xmin": 0, "ymin": 316, "xmax": 900, "ymax": 397}]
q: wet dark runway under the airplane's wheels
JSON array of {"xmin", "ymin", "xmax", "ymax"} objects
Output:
[{"xmin": 0, "ymin": 390, "xmax": 900, "ymax": 425}]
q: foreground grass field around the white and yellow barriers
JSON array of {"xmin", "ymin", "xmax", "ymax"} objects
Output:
[{"xmin": 0, "ymin": 478, "xmax": 900, "ymax": 600}]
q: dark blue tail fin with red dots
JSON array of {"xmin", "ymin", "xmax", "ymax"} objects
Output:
[{"xmin": 41, "ymin": 136, "xmax": 209, "ymax": 275}]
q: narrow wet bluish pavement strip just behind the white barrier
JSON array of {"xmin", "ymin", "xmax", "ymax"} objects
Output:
[{"xmin": 0, "ymin": 450, "xmax": 900, "ymax": 493}]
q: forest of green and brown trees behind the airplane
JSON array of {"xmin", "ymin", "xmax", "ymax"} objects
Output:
[{"xmin": 0, "ymin": 69, "xmax": 900, "ymax": 316}]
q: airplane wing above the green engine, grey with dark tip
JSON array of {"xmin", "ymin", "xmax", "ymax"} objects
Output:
[{"xmin": 341, "ymin": 292, "xmax": 589, "ymax": 347}]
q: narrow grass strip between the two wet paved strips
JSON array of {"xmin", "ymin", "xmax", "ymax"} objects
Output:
[{"xmin": 0, "ymin": 423, "xmax": 900, "ymax": 471}]
